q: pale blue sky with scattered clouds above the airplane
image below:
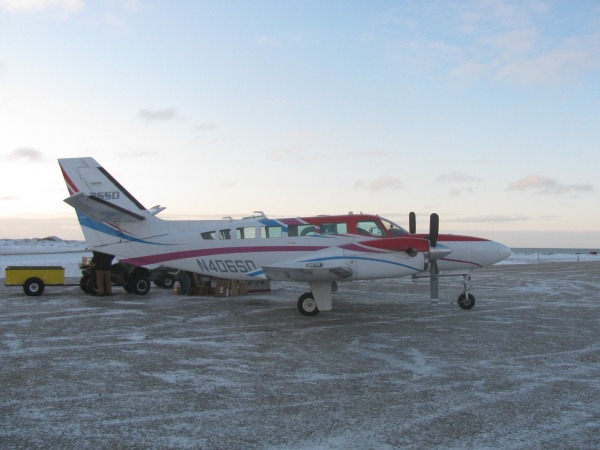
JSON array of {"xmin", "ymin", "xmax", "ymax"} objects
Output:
[{"xmin": 0, "ymin": 0, "xmax": 600, "ymax": 248}]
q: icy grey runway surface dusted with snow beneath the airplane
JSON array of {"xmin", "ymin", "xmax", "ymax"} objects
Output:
[{"xmin": 0, "ymin": 262, "xmax": 600, "ymax": 449}]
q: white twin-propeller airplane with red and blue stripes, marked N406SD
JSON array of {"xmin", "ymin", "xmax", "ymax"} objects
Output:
[{"xmin": 58, "ymin": 157, "xmax": 511, "ymax": 316}]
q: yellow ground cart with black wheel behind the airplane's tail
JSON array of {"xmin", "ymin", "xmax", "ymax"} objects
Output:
[{"xmin": 4, "ymin": 266, "xmax": 65, "ymax": 296}]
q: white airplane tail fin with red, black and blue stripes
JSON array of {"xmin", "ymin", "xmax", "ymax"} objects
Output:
[{"xmin": 58, "ymin": 158, "xmax": 160, "ymax": 251}]
